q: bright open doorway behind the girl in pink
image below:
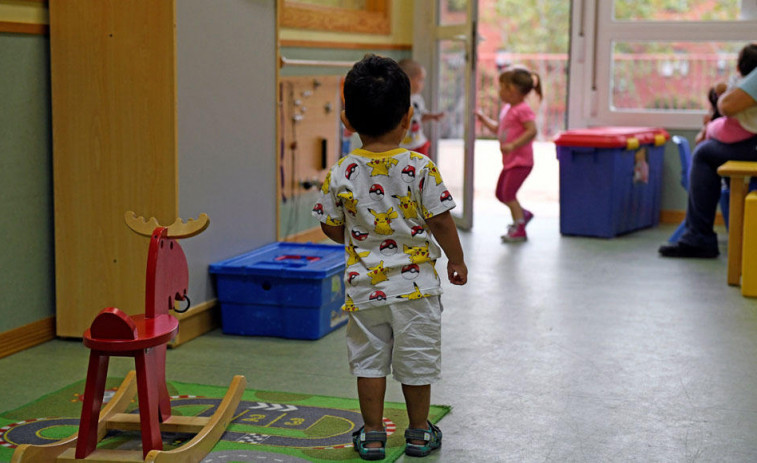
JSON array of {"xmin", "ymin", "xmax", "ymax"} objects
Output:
[{"xmin": 474, "ymin": 0, "xmax": 570, "ymax": 227}]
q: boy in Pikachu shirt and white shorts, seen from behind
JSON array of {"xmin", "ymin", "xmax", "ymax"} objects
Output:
[{"xmin": 313, "ymin": 55, "xmax": 468, "ymax": 460}]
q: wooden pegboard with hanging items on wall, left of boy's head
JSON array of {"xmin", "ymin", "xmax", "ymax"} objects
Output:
[{"xmin": 279, "ymin": 76, "xmax": 342, "ymax": 202}]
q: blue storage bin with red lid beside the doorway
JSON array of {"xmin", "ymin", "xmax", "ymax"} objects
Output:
[{"xmin": 555, "ymin": 127, "xmax": 670, "ymax": 238}]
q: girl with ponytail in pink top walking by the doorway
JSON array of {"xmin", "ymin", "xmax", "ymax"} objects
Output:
[{"xmin": 476, "ymin": 67, "xmax": 542, "ymax": 242}]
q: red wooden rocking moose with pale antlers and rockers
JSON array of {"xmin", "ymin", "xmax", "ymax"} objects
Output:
[{"xmin": 11, "ymin": 212, "xmax": 246, "ymax": 463}]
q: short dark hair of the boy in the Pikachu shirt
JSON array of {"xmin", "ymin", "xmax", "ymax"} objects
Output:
[{"xmin": 344, "ymin": 55, "xmax": 410, "ymax": 137}]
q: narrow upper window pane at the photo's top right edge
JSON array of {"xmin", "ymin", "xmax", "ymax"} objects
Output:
[{"xmin": 614, "ymin": 0, "xmax": 755, "ymax": 21}]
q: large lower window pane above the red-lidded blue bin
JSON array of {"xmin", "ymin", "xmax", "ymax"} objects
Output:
[{"xmin": 611, "ymin": 42, "xmax": 744, "ymax": 111}]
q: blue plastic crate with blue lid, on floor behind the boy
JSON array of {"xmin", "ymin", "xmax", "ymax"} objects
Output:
[{"xmin": 210, "ymin": 242, "xmax": 347, "ymax": 339}]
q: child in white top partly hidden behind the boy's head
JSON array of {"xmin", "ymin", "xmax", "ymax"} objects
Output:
[{"xmin": 399, "ymin": 58, "xmax": 444, "ymax": 156}]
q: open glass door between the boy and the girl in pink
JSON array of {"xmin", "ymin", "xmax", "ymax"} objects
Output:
[{"xmin": 428, "ymin": 0, "xmax": 478, "ymax": 230}]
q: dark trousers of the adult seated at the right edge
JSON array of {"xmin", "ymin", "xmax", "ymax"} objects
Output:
[{"xmin": 680, "ymin": 136, "xmax": 757, "ymax": 249}]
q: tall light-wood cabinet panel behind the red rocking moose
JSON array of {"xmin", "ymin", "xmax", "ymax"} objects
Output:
[{"xmin": 50, "ymin": 0, "xmax": 178, "ymax": 337}]
